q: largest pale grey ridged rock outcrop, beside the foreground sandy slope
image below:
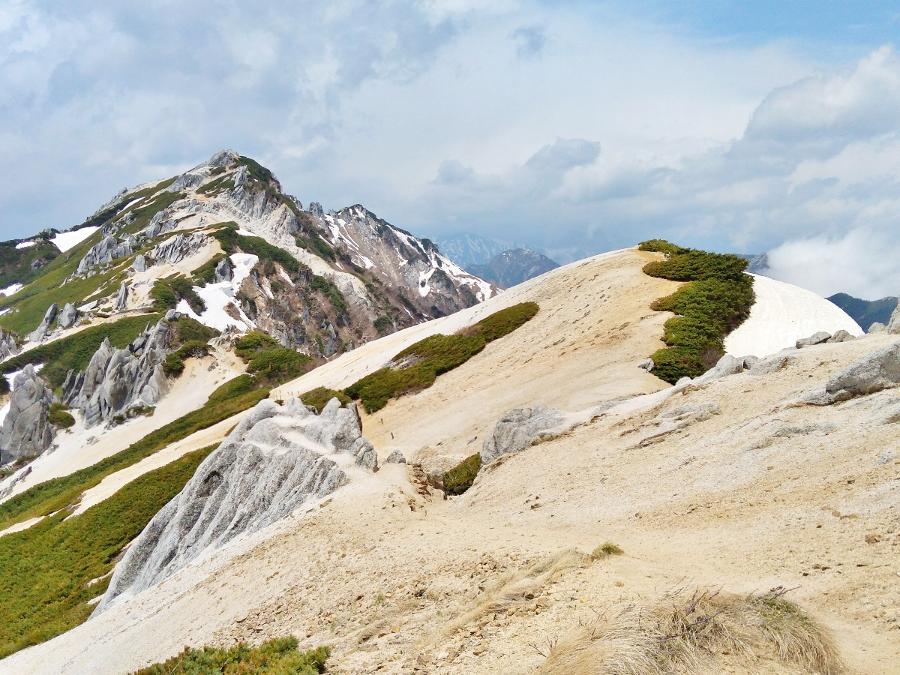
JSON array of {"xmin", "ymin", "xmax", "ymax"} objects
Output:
[{"xmin": 95, "ymin": 399, "xmax": 374, "ymax": 613}]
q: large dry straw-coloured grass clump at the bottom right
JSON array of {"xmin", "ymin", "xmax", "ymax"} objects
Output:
[{"xmin": 541, "ymin": 588, "xmax": 842, "ymax": 675}]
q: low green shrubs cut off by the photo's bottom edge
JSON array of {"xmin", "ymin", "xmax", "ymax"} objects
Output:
[{"xmin": 134, "ymin": 637, "xmax": 329, "ymax": 675}]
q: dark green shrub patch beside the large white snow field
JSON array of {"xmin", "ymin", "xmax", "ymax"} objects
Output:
[{"xmin": 639, "ymin": 239, "xmax": 754, "ymax": 384}]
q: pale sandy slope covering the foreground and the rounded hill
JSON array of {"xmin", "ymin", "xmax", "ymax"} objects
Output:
[{"xmin": 0, "ymin": 250, "xmax": 900, "ymax": 673}]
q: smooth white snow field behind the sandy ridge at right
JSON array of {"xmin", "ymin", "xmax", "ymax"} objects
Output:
[{"xmin": 725, "ymin": 274, "xmax": 864, "ymax": 358}]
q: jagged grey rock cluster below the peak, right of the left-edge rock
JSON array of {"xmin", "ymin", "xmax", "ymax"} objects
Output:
[{"xmin": 63, "ymin": 320, "xmax": 169, "ymax": 426}]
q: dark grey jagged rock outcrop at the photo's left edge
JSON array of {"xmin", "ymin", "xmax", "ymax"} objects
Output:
[{"xmin": 0, "ymin": 364, "xmax": 53, "ymax": 464}]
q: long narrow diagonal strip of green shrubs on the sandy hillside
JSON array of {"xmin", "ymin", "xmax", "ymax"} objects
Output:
[{"xmin": 345, "ymin": 302, "xmax": 538, "ymax": 413}]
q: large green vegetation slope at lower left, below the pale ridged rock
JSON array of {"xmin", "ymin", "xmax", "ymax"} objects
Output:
[{"xmin": 0, "ymin": 446, "xmax": 215, "ymax": 658}]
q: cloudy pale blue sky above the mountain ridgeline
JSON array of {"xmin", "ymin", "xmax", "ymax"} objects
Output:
[{"xmin": 0, "ymin": 0, "xmax": 900, "ymax": 297}]
